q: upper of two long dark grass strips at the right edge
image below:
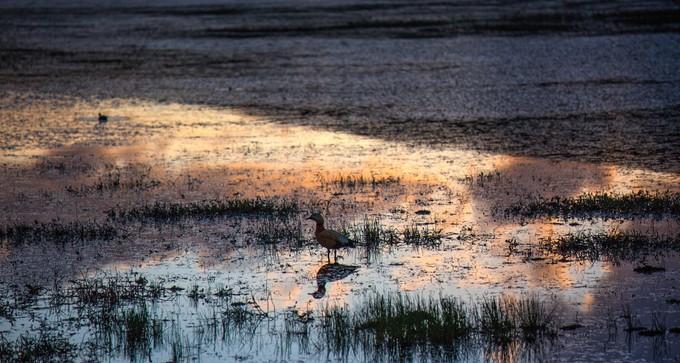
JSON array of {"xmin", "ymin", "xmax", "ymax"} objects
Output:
[{"xmin": 505, "ymin": 191, "xmax": 680, "ymax": 218}]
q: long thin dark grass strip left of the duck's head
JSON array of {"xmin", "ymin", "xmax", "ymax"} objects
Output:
[{"xmin": 107, "ymin": 198, "xmax": 300, "ymax": 223}]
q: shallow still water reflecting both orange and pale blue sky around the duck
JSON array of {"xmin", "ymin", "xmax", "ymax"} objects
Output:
[{"xmin": 1, "ymin": 100, "xmax": 678, "ymax": 360}]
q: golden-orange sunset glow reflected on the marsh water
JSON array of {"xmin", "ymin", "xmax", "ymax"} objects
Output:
[{"xmin": 0, "ymin": 96, "xmax": 680, "ymax": 307}]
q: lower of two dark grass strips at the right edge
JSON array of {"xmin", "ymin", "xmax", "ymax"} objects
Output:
[{"xmin": 541, "ymin": 231, "xmax": 680, "ymax": 263}]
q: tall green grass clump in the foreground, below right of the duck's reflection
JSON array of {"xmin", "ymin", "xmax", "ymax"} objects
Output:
[{"xmin": 320, "ymin": 293, "xmax": 557, "ymax": 359}]
